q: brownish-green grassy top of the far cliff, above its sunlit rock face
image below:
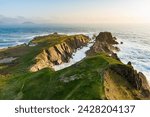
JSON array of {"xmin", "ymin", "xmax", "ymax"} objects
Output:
[{"xmin": 0, "ymin": 34, "xmax": 89, "ymax": 74}]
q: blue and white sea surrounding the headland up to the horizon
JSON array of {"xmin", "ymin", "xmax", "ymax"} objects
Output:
[{"xmin": 0, "ymin": 24, "xmax": 150, "ymax": 81}]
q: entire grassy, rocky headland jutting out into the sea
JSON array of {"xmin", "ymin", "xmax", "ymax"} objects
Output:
[{"xmin": 0, "ymin": 32, "xmax": 150, "ymax": 100}]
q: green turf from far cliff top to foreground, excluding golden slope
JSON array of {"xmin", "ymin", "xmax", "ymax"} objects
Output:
[{"xmin": 0, "ymin": 34, "xmax": 126, "ymax": 100}]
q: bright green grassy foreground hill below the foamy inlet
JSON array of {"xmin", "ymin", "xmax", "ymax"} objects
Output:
[{"xmin": 0, "ymin": 55, "xmax": 108, "ymax": 100}]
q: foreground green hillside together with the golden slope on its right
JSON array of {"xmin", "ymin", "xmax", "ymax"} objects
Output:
[{"xmin": 0, "ymin": 53, "xmax": 142, "ymax": 100}]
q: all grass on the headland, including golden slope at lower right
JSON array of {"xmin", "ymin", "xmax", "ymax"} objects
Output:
[{"xmin": 0, "ymin": 34, "xmax": 149, "ymax": 100}]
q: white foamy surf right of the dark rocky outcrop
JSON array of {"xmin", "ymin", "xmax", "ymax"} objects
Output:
[{"xmin": 118, "ymin": 37, "xmax": 150, "ymax": 83}]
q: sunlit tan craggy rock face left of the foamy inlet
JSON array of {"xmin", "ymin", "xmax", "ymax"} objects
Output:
[{"xmin": 30, "ymin": 35, "xmax": 89, "ymax": 72}]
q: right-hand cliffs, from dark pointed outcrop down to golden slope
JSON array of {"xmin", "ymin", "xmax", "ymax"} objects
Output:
[{"xmin": 88, "ymin": 32, "xmax": 150, "ymax": 99}]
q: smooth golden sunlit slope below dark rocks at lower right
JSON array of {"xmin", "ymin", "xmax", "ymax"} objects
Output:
[{"xmin": 103, "ymin": 69, "xmax": 135, "ymax": 100}]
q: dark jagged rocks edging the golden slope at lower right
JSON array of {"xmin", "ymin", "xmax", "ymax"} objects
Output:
[{"xmin": 104, "ymin": 64, "xmax": 150, "ymax": 99}]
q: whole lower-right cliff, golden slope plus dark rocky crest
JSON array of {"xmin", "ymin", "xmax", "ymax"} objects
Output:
[{"xmin": 104, "ymin": 64, "xmax": 150, "ymax": 99}]
